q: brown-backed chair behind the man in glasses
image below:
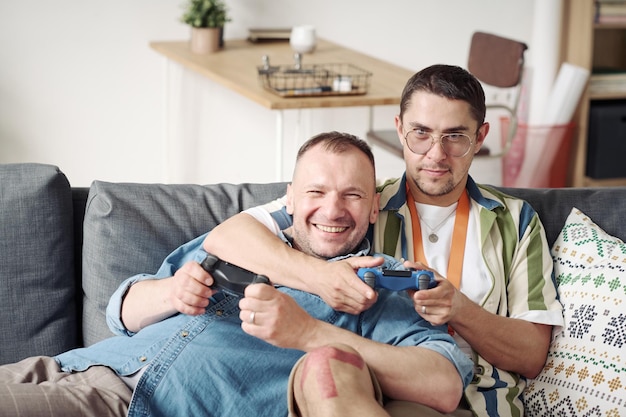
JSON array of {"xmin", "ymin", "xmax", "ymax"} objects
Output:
[{"xmin": 367, "ymin": 32, "xmax": 528, "ymax": 158}]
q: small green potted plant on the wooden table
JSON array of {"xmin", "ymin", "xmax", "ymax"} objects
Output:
[{"xmin": 181, "ymin": 0, "xmax": 230, "ymax": 54}]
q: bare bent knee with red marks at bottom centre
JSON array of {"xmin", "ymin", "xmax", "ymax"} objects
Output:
[{"xmin": 289, "ymin": 345, "xmax": 388, "ymax": 417}]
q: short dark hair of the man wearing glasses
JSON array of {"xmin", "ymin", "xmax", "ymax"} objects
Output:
[{"xmin": 400, "ymin": 64, "xmax": 487, "ymax": 126}]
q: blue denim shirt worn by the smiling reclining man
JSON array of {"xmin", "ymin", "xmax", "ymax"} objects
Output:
[{"xmin": 55, "ymin": 235, "xmax": 472, "ymax": 417}]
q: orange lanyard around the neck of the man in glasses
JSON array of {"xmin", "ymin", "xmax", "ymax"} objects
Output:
[{"xmin": 406, "ymin": 184, "xmax": 470, "ymax": 289}]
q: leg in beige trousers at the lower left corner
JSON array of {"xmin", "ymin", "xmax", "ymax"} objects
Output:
[{"xmin": 0, "ymin": 356, "xmax": 132, "ymax": 417}]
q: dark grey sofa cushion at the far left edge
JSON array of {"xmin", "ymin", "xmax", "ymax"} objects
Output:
[{"xmin": 0, "ymin": 164, "xmax": 77, "ymax": 363}]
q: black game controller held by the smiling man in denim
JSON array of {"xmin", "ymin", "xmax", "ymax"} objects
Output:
[{"xmin": 200, "ymin": 254, "xmax": 270, "ymax": 296}]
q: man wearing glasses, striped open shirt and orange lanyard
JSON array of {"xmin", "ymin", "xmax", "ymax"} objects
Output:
[{"xmin": 205, "ymin": 65, "xmax": 563, "ymax": 416}]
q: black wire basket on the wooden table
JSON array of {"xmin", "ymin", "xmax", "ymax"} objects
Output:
[{"xmin": 257, "ymin": 64, "xmax": 372, "ymax": 97}]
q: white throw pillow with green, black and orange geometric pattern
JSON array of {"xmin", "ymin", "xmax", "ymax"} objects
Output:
[{"xmin": 524, "ymin": 208, "xmax": 626, "ymax": 417}]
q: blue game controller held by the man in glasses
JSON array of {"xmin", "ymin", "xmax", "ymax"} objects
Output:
[{"xmin": 356, "ymin": 267, "xmax": 437, "ymax": 291}]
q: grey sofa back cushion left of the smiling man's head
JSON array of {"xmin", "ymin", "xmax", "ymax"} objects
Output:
[{"xmin": 82, "ymin": 181, "xmax": 286, "ymax": 345}]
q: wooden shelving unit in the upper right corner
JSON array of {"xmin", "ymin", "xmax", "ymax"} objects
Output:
[{"xmin": 561, "ymin": 0, "xmax": 626, "ymax": 187}]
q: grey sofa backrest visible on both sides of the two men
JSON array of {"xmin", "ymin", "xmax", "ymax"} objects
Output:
[{"xmin": 83, "ymin": 181, "xmax": 626, "ymax": 345}]
